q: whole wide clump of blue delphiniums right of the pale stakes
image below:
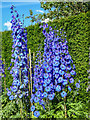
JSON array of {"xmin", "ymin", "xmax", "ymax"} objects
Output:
[{"xmin": 30, "ymin": 23, "xmax": 79, "ymax": 117}]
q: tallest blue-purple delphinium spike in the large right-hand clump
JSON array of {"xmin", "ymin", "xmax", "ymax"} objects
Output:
[{"xmin": 43, "ymin": 24, "xmax": 54, "ymax": 95}]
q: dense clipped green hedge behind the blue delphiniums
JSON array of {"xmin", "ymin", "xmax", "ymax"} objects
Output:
[{"xmin": 2, "ymin": 11, "xmax": 90, "ymax": 118}]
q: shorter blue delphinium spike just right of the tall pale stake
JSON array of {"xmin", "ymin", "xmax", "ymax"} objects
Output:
[{"xmin": 30, "ymin": 48, "xmax": 44, "ymax": 117}]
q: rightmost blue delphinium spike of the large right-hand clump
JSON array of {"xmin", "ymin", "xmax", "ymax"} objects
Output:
[{"xmin": 61, "ymin": 38, "xmax": 76, "ymax": 97}]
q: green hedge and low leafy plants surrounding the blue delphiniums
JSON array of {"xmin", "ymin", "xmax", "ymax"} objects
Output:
[{"xmin": 2, "ymin": 9, "xmax": 90, "ymax": 118}]
